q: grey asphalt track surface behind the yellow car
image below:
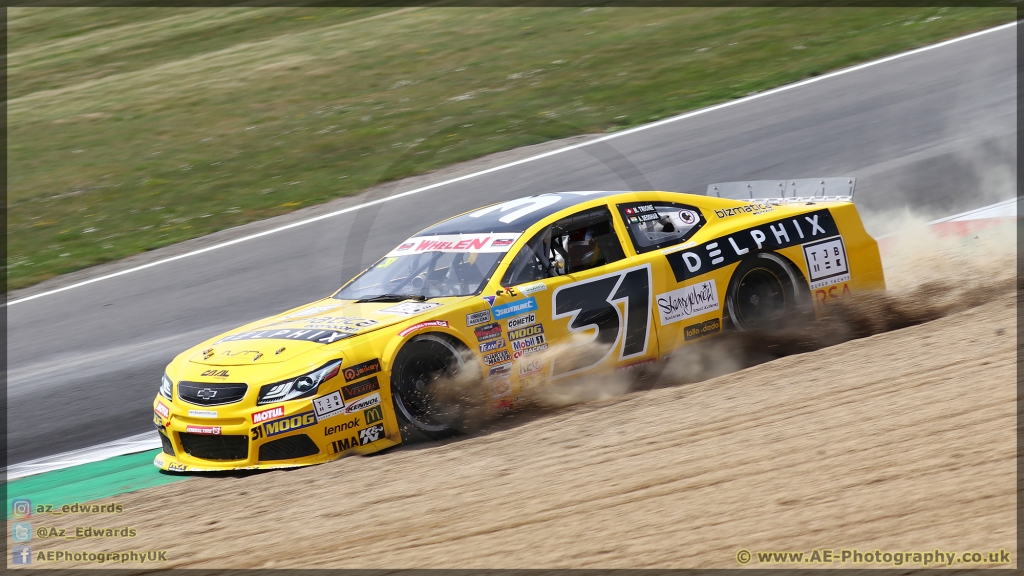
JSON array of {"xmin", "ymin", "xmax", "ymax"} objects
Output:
[{"xmin": 7, "ymin": 27, "xmax": 1017, "ymax": 463}]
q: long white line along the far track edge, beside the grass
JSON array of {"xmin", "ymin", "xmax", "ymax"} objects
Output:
[{"xmin": 4, "ymin": 22, "xmax": 1017, "ymax": 306}]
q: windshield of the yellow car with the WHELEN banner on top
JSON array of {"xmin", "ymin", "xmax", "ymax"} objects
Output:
[{"xmin": 334, "ymin": 233, "xmax": 519, "ymax": 301}]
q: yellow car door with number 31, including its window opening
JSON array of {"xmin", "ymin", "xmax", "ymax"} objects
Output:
[{"xmin": 492, "ymin": 205, "xmax": 657, "ymax": 389}]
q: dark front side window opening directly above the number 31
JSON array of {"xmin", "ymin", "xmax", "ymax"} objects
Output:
[{"xmin": 502, "ymin": 207, "xmax": 626, "ymax": 286}]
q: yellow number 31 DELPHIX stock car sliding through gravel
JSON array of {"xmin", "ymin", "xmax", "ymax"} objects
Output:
[{"xmin": 153, "ymin": 178, "xmax": 885, "ymax": 471}]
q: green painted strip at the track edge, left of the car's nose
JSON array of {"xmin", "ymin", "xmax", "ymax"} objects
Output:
[{"xmin": 6, "ymin": 449, "xmax": 188, "ymax": 520}]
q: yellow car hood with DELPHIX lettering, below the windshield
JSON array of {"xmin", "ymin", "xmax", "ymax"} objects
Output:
[{"xmin": 188, "ymin": 296, "xmax": 466, "ymax": 366}]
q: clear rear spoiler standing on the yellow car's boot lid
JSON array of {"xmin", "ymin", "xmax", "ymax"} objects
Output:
[{"xmin": 708, "ymin": 176, "xmax": 857, "ymax": 204}]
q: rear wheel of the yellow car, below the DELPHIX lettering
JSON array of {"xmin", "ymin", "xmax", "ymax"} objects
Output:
[{"xmin": 725, "ymin": 252, "xmax": 810, "ymax": 330}]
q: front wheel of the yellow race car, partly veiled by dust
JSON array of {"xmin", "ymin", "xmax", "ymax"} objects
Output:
[{"xmin": 391, "ymin": 334, "xmax": 486, "ymax": 441}]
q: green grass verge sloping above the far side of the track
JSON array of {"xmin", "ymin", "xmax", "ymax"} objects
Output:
[{"xmin": 6, "ymin": 8, "xmax": 1016, "ymax": 290}]
